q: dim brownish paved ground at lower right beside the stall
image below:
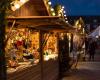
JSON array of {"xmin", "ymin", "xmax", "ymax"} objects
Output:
[{"xmin": 62, "ymin": 52, "xmax": 100, "ymax": 80}]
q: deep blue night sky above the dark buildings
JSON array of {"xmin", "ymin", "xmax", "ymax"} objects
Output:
[{"xmin": 51, "ymin": 0, "xmax": 100, "ymax": 16}]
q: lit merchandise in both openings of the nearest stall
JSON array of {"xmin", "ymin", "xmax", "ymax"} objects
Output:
[{"xmin": 5, "ymin": 28, "xmax": 58, "ymax": 73}]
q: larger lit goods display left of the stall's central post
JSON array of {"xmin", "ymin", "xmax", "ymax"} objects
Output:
[{"xmin": 5, "ymin": 28, "xmax": 40, "ymax": 72}]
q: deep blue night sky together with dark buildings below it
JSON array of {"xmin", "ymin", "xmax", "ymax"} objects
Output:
[{"xmin": 50, "ymin": 0, "xmax": 100, "ymax": 32}]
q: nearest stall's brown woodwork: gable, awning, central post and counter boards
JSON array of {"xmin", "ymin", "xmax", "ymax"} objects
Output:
[{"xmin": 7, "ymin": 0, "xmax": 74, "ymax": 80}]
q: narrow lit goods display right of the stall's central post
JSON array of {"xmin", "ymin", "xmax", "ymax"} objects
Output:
[{"xmin": 44, "ymin": 33, "xmax": 58, "ymax": 61}]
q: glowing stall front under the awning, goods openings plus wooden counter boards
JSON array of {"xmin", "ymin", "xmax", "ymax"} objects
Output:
[{"xmin": 6, "ymin": 28, "xmax": 59, "ymax": 80}]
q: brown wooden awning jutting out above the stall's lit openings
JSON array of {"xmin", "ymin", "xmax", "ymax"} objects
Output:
[{"xmin": 7, "ymin": 16, "xmax": 74, "ymax": 32}]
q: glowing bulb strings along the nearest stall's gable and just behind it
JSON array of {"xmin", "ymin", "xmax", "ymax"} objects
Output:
[{"xmin": 11, "ymin": 0, "xmax": 68, "ymax": 23}]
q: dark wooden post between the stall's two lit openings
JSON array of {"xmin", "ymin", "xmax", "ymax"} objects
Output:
[{"xmin": 39, "ymin": 30, "xmax": 43, "ymax": 80}]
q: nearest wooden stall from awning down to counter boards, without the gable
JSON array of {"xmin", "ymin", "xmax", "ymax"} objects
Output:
[{"xmin": 6, "ymin": 16, "xmax": 73, "ymax": 80}]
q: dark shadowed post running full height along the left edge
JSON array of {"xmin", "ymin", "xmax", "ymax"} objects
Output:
[{"xmin": 0, "ymin": 0, "xmax": 10, "ymax": 80}]
